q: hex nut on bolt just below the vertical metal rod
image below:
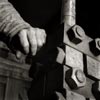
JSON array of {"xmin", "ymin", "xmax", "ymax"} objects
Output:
[{"xmin": 67, "ymin": 25, "xmax": 85, "ymax": 44}]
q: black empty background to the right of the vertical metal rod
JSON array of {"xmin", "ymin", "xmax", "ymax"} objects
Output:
[{"xmin": 76, "ymin": 0, "xmax": 100, "ymax": 38}]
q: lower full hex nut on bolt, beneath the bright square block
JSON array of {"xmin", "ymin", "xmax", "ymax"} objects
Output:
[{"xmin": 65, "ymin": 68, "xmax": 86, "ymax": 89}]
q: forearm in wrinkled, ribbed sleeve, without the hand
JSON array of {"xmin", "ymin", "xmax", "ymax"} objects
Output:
[{"xmin": 0, "ymin": 0, "xmax": 30, "ymax": 38}]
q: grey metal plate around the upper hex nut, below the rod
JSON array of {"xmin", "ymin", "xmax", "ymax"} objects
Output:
[{"xmin": 63, "ymin": 24, "xmax": 100, "ymax": 61}]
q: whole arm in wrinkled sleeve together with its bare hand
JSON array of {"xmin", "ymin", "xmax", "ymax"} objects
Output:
[{"xmin": 0, "ymin": 0, "xmax": 46, "ymax": 55}]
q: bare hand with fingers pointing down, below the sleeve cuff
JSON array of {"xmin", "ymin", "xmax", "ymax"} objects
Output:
[{"xmin": 10, "ymin": 28, "xmax": 46, "ymax": 58}]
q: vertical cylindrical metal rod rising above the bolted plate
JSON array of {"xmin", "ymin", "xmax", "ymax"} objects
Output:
[{"xmin": 62, "ymin": 0, "xmax": 76, "ymax": 26}]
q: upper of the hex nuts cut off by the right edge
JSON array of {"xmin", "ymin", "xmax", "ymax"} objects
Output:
[{"xmin": 89, "ymin": 38, "xmax": 100, "ymax": 56}]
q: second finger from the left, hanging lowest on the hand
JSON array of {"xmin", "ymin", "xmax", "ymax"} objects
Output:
[{"xmin": 28, "ymin": 28, "xmax": 37, "ymax": 56}]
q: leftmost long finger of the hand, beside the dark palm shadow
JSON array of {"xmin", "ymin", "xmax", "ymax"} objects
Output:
[{"xmin": 19, "ymin": 29, "xmax": 29, "ymax": 54}]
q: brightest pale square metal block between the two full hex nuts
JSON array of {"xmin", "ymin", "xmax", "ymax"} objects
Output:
[{"xmin": 65, "ymin": 45, "xmax": 83, "ymax": 70}]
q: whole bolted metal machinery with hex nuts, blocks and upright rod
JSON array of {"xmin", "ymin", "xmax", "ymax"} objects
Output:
[{"xmin": 57, "ymin": 0, "xmax": 100, "ymax": 100}]
